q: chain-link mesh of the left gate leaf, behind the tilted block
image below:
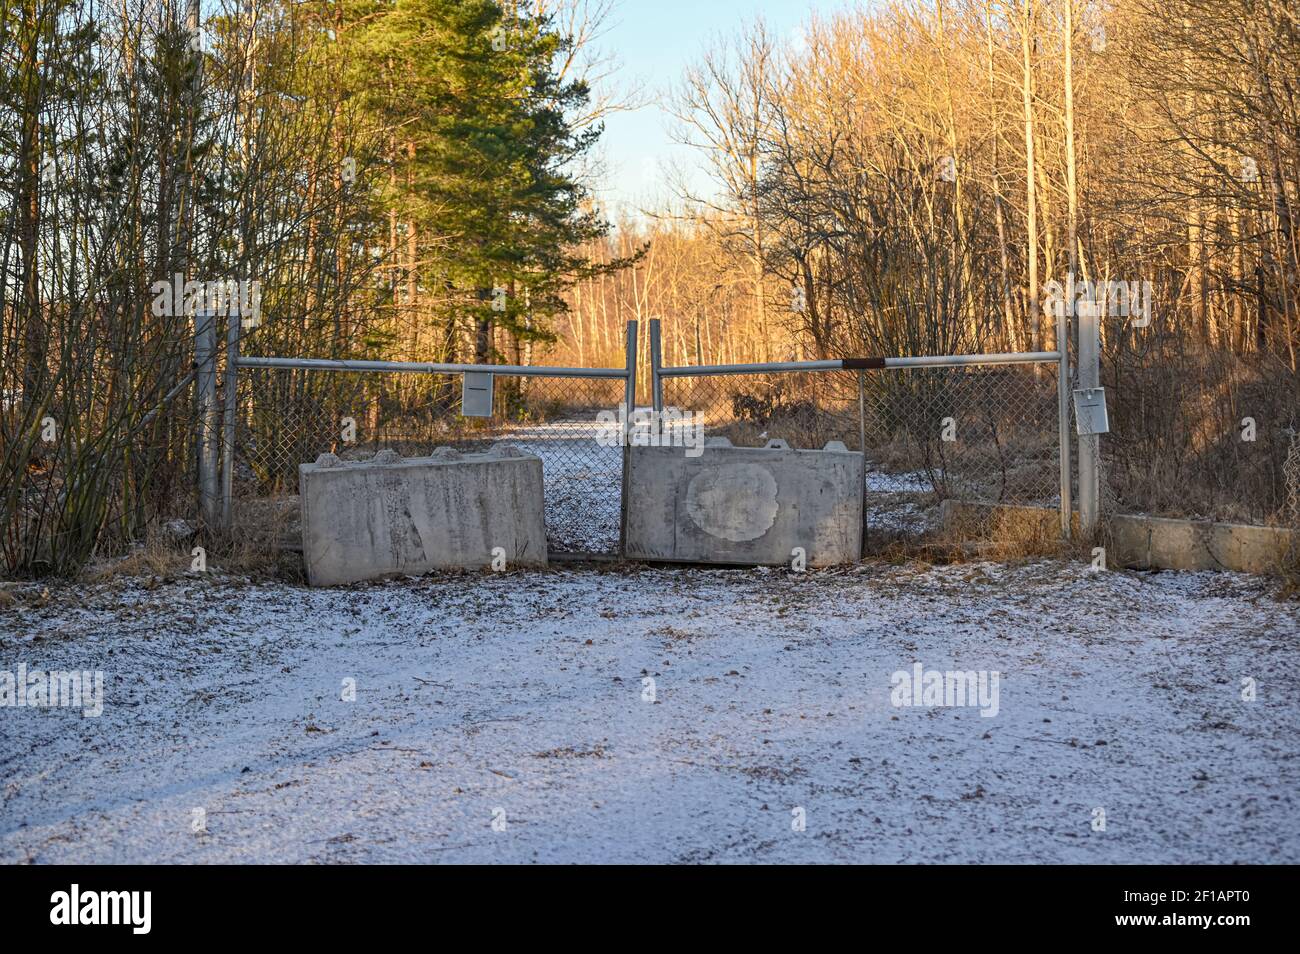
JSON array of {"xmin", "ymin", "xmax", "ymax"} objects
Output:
[{"xmin": 233, "ymin": 368, "xmax": 624, "ymax": 555}]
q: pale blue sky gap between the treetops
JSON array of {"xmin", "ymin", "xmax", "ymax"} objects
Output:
[{"xmin": 582, "ymin": 0, "xmax": 853, "ymax": 212}]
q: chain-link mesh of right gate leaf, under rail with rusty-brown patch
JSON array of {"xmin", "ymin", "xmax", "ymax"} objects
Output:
[{"xmin": 663, "ymin": 363, "xmax": 1061, "ymax": 541}]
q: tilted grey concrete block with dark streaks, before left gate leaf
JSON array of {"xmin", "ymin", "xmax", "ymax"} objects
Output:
[{"xmin": 298, "ymin": 445, "xmax": 546, "ymax": 586}]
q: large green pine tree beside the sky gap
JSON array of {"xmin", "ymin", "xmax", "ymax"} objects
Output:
[{"xmin": 352, "ymin": 0, "xmax": 627, "ymax": 361}]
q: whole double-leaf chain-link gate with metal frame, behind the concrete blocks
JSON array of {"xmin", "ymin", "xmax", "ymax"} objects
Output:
[{"xmin": 210, "ymin": 314, "xmax": 1070, "ymax": 556}]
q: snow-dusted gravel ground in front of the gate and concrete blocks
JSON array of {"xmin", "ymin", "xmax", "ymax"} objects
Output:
[{"xmin": 0, "ymin": 561, "xmax": 1300, "ymax": 863}]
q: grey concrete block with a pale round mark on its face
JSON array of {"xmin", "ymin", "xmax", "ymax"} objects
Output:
[{"xmin": 625, "ymin": 441, "xmax": 865, "ymax": 567}]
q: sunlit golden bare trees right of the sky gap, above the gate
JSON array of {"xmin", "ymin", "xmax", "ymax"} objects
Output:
[{"xmin": 563, "ymin": 0, "xmax": 1300, "ymax": 370}]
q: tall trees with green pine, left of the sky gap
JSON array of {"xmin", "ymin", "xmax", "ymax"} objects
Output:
[{"xmin": 0, "ymin": 0, "xmax": 624, "ymax": 571}]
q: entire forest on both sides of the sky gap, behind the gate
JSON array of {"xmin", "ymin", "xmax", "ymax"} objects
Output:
[{"xmin": 0, "ymin": 0, "xmax": 1300, "ymax": 571}]
